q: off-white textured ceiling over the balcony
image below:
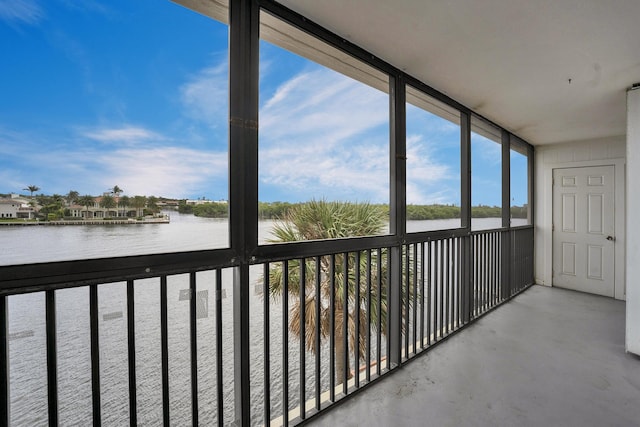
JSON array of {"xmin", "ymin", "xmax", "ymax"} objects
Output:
[{"xmin": 281, "ymin": 0, "xmax": 640, "ymax": 145}]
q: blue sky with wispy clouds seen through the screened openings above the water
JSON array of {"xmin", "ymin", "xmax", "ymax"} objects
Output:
[{"xmin": 0, "ymin": 0, "xmax": 523, "ymax": 205}]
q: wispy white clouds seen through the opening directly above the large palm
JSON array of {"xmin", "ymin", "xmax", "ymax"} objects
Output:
[{"xmin": 259, "ymin": 69, "xmax": 389, "ymax": 202}]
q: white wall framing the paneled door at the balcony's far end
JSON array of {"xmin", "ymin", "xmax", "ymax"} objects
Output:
[{"xmin": 534, "ymin": 136, "xmax": 628, "ymax": 299}]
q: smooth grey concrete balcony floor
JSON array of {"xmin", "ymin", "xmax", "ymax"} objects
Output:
[{"xmin": 310, "ymin": 286, "xmax": 640, "ymax": 427}]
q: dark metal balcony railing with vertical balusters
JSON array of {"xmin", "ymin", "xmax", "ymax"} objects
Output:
[{"xmin": 0, "ymin": 227, "xmax": 533, "ymax": 425}]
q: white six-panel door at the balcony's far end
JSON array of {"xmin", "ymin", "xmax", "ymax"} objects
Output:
[{"xmin": 553, "ymin": 166, "xmax": 615, "ymax": 297}]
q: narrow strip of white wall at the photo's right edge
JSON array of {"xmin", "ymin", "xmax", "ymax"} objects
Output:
[{"xmin": 626, "ymin": 89, "xmax": 640, "ymax": 355}]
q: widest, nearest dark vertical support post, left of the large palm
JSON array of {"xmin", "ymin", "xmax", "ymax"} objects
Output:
[{"xmin": 229, "ymin": 0, "xmax": 260, "ymax": 426}]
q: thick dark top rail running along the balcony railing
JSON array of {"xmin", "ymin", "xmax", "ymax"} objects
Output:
[{"xmin": 0, "ymin": 225, "xmax": 534, "ymax": 295}]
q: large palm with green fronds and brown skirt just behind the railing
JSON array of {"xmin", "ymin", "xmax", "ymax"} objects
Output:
[{"xmin": 269, "ymin": 200, "xmax": 387, "ymax": 382}]
